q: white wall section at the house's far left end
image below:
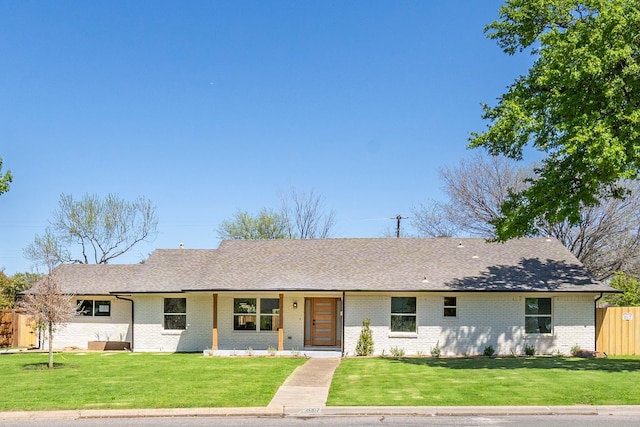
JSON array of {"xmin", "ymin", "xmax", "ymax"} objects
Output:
[{"xmin": 49, "ymin": 295, "xmax": 131, "ymax": 349}]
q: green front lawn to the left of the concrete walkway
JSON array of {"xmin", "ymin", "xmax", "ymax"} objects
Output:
[{"xmin": 0, "ymin": 353, "xmax": 306, "ymax": 411}]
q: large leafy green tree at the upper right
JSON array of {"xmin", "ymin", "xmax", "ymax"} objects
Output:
[{"xmin": 470, "ymin": 0, "xmax": 640, "ymax": 240}]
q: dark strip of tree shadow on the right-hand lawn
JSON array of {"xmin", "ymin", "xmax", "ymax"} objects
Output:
[{"xmin": 385, "ymin": 357, "xmax": 640, "ymax": 372}]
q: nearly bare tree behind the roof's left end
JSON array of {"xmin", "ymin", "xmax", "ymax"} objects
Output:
[{"xmin": 24, "ymin": 194, "xmax": 158, "ymax": 265}]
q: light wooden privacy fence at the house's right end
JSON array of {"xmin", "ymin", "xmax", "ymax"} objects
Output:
[{"xmin": 596, "ymin": 307, "xmax": 640, "ymax": 356}]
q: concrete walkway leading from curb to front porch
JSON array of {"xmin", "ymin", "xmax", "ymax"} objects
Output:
[{"xmin": 267, "ymin": 358, "xmax": 341, "ymax": 413}]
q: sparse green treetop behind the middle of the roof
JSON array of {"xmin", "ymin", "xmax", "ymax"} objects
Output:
[{"xmin": 218, "ymin": 209, "xmax": 289, "ymax": 240}]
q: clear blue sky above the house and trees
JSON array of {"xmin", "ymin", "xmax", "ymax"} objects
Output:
[{"xmin": 0, "ymin": 0, "xmax": 531, "ymax": 274}]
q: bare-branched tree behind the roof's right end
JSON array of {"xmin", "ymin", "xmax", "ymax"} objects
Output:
[{"xmin": 411, "ymin": 155, "xmax": 640, "ymax": 280}]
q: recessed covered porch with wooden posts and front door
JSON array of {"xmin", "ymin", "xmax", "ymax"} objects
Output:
[{"xmin": 207, "ymin": 291, "xmax": 344, "ymax": 357}]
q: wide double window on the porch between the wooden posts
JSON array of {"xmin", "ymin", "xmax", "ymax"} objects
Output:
[{"xmin": 233, "ymin": 298, "xmax": 280, "ymax": 331}]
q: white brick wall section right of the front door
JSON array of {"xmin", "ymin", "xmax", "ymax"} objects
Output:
[{"xmin": 344, "ymin": 292, "xmax": 596, "ymax": 356}]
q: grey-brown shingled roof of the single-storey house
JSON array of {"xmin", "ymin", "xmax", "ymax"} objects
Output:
[{"xmin": 51, "ymin": 238, "xmax": 614, "ymax": 293}]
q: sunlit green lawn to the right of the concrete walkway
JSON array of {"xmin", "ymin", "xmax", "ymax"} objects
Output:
[{"xmin": 327, "ymin": 357, "xmax": 640, "ymax": 406}]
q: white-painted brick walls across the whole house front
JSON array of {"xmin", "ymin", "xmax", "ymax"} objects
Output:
[{"xmin": 47, "ymin": 292, "xmax": 597, "ymax": 356}]
